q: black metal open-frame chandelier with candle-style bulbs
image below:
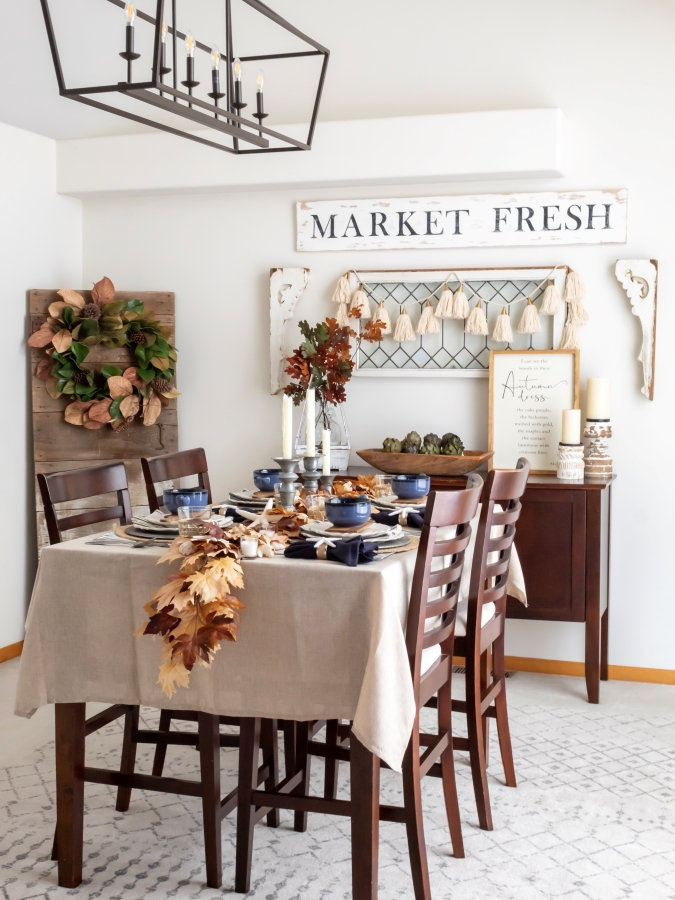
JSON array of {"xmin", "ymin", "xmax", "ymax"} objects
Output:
[{"xmin": 40, "ymin": 0, "xmax": 330, "ymax": 154}]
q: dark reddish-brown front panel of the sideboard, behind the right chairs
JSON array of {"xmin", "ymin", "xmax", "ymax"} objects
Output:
[{"xmin": 507, "ymin": 486, "xmax": 586, "ymax": 622}]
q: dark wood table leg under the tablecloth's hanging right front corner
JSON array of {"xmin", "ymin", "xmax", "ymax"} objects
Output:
[{"xmin": 349, "ymin": 734, "xmax": 380, "ymax": 900}]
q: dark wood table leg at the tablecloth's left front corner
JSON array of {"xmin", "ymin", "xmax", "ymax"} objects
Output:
[{"xmin": 55, "ymin": 703, "xmax": 86, "ymax": 888}]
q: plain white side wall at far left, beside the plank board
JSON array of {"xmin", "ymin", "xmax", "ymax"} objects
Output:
[{"xmin": 0, "ymin": 124, "xmax": 82, "ymax": 647}]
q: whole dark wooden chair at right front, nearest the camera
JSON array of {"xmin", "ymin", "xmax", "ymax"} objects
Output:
[{"xmin": 235, "ymin": 475, "xmax": 483, "ymax": 900}]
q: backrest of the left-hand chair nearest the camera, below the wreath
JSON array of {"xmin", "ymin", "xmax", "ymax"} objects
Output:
[{"xmin": 37, "ymin": 463, "xmax": 131, "ymax": 544}]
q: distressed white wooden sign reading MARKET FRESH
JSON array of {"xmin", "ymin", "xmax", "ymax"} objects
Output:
[{"xmin": 297, "ymin": 189, "xmax": 628, "ymax": 250}]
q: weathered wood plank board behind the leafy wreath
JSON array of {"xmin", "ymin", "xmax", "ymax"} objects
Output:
[{"xmin": 28, "ymin": 290, "xmax": 178, "ymax": 552}]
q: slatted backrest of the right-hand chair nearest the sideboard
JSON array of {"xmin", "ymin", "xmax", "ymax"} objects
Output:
[{"xmin": 466, "ymin": 457, "xmax": 530, "ymax": 659}]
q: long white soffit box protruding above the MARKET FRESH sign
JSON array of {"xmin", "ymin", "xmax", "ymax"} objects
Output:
[{"xmin": 57, "ymin": 109, "xmax": 567, "ymax": 198}]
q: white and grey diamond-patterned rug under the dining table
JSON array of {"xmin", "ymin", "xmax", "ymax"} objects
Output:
[{"xmin": 0, "ymin": 697, "xmax": 675, "ymax": 900}]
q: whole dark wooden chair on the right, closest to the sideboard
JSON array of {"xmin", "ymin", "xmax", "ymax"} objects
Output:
[{"xmin": 448, "ymin": 458, "xmax": 530, "ymax": 831}]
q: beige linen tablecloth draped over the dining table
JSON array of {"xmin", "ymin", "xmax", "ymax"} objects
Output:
[{"xmin": 15, "ymin": 524, "xmax": 524, "ymax": 771}]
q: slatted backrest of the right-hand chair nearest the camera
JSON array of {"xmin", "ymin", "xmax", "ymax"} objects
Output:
[{"xmin": 406, "ymin": 474, "xmax": 483, "ymax": 686}]
